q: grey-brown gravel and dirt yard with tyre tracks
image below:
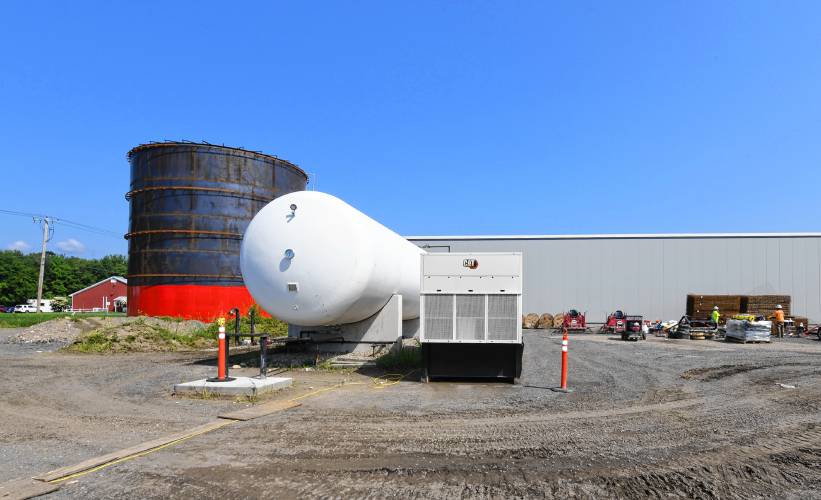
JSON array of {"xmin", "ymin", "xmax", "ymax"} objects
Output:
[{"xmin": 0, "ymin": 331, "xmax": 821, "ymax": 498}]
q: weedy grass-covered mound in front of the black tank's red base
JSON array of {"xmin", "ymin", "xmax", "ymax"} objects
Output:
[{"xmin": 63, "ymin": 319, "xmax": 216, "ymax": 353}]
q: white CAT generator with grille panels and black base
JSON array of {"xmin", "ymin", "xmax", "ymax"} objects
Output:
[{"xmin": 419, "ymin": 252, "xmax": 523, "ymax": 383}]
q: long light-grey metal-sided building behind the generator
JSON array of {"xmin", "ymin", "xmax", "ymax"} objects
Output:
[{"xmin": 408, "ymin": 233, "xmax": 821, "ymax": 323}]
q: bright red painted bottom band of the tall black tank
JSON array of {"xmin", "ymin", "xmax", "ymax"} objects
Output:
[{"xmin": 128, "ymin": 285, "xmax": 267, "ymax": 321}]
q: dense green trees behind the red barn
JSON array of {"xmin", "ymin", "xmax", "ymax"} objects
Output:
[{"xmin": 0, "ymin": 250, "xmax": 128, "ymax": 306}]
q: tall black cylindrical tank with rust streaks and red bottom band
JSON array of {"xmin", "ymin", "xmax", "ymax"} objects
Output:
[{"xmin": 125, "ymin": 142, "xmax": 308, "ymax": 321}]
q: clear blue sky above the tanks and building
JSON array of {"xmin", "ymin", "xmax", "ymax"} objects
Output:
[{"xmin": 0, "ymin": 1, "xmax": 821, "ymax": 257}]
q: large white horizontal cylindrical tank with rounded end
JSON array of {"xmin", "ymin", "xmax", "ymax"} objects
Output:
[{"xmin": 240, "ymin": 191, "xmax": 425, "ymax": 326}]
